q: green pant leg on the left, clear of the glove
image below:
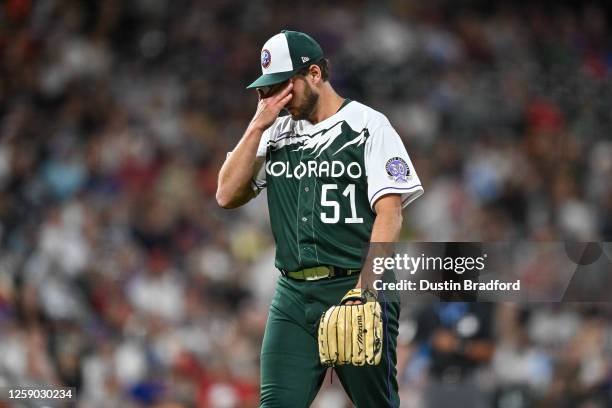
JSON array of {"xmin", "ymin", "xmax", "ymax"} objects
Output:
[{"xmin": 261, "ymin": 277, "xmax": 325, "ymax": 408}]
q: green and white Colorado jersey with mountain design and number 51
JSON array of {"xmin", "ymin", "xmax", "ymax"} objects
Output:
[{"xmin": 253, "ymin": 100, "xmax": 423, "ymax": 271}]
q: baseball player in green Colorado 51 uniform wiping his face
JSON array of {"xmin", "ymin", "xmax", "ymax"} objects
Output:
[{"xmin": 217, "ymin": 31, "xmax": 423, "ymax": 408}]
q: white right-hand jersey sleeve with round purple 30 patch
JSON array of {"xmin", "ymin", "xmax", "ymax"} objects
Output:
[{"xmin": 364, "ymin": 124, "xmax": 423, "ymax": 210}]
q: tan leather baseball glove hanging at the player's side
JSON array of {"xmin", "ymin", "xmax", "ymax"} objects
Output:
[{"xmin": 318, "ymin": 289, "xmax": 383, "ymax": 367}]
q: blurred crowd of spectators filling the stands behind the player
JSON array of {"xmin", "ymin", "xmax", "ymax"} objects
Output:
[{"xmin": 0, "ymin": 0, "xmax": 612, "ymax": 408}]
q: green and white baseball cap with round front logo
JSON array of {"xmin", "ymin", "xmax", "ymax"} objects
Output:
[{"xmin": 247, "ymin": 30, "xmax": 323, "ymax": 89}]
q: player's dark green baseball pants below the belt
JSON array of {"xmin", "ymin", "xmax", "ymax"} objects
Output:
[{"xmin": 260, "ymin": 275, "xmax": 400, "ymax": 408}]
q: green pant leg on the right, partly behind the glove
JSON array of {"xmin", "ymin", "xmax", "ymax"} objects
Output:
[{"xmin": 335, "ymin": 296, "xmax": 400, "ymax": 408}]
